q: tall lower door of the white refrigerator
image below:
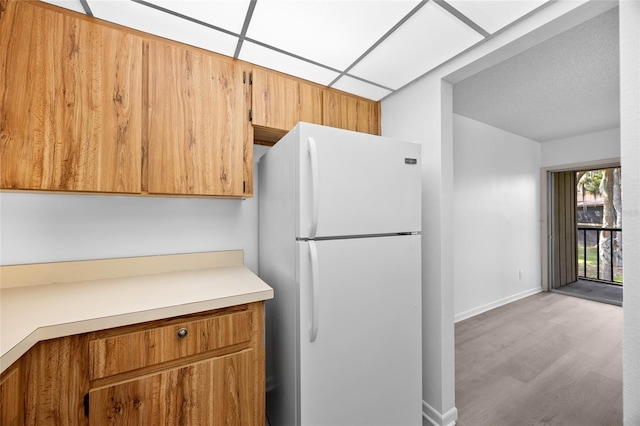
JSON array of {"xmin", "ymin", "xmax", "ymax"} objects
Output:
[{"xmin": 298, "ymin": 235, "xmax": 422, "ymax": 426}]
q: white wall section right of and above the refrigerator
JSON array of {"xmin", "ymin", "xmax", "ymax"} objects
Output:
[{"xmin": 382, "ymin": 78, "xmax": 457, "ymax": 425}]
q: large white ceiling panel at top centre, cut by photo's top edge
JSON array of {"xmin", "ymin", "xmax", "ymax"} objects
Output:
[{"xmin": 247, "ymin": 0, "xmax": 419, "ymax": 70}]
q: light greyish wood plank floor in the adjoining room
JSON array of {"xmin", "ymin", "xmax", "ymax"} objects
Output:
[{"xmin": 455, "ymin": 292, "xmax": 622, "ymax": 426}]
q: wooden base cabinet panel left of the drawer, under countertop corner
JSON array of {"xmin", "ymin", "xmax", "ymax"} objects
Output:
[{"xmin": 24, "ymin": 335, "xmax": 89, "ymax": 426}]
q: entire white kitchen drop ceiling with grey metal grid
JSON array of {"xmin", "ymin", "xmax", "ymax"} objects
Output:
[{"xmin": 43, "ymin": 0, "xmax": 549, "ymax": 101}]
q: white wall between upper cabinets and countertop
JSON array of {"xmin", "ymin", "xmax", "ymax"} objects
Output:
[{"xmin": 0, "ymin": 145, "xmax": 267, "ymax": 272}]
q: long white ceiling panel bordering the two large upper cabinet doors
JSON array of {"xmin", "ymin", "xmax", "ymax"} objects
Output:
[{"xmin": 87, "ymin": 0, "xmax": 238, "ymax": 56}]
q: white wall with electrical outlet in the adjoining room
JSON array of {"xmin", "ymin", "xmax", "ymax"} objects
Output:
[{"xmin": 453, "ymin": 114, "xmax": 542, "ymax": 321}]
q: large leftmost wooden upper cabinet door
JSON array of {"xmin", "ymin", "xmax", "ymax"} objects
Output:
[{"xmin": 0, "ymin": 0, "xmax": 142, "ymax": 193}]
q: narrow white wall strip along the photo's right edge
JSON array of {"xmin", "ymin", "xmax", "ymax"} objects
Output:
[{"xmin": 620, "ymin": 1, "xmax": 640, "ymax": 425}]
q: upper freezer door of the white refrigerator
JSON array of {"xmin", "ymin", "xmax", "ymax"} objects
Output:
[{"xmin": 294, "ymin": 123, "xmax": 422, "ymax": 238}]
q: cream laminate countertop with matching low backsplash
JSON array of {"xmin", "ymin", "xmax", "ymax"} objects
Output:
[{"xmin": 0, "ymin": 251, "xmax": 273, "ymax": 373}]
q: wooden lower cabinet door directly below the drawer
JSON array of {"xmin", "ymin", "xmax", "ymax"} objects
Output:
[{"xmin": 89, "ymin": 350, "xmax": 264, "ymax": 426}]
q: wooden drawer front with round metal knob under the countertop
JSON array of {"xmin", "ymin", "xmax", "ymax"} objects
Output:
[{"xmin": 89, "ymin": 311, "xmax": 252, "ymax": 380}]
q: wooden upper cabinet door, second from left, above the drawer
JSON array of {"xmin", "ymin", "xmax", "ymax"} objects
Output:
[{"xmin": 145, "ymin": 40, "xmax": 252, "ymax": 196}]
